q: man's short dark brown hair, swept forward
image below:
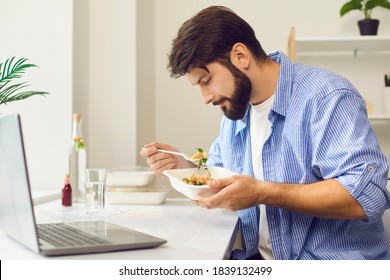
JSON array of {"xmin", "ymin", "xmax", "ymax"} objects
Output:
[{"xmin": 168, "ymin": 6, "xmax": 267, "ymax": 78}]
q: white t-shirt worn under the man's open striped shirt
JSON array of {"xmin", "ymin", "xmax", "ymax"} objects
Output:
[{"xmin": 250, "ymin": 95, "xmax": 275, "ymax": 260}]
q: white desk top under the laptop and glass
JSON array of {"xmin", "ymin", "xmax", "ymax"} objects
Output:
[{"xmin": 0, "ymin": 198, "xmax": 238, "ymax": 260}]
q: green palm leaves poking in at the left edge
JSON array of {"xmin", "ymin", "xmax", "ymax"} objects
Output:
[{"xmin": 0, "ymin": 57, "xmax": 49, "ymax": 108}]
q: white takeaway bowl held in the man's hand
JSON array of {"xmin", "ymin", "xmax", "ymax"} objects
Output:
[{"xmin": 163, "ymin": 166, "xmax": 236, "ymax": 200}]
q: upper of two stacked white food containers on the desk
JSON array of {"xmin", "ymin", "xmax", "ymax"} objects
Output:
[{"xmin": 106, "ymin": 166, "xmax": 155, "ymax": 187}]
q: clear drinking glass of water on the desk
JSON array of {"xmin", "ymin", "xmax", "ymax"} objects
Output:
[{"xmin": 85, "ymin": 168, "xmax": 106, "ymax": 215}]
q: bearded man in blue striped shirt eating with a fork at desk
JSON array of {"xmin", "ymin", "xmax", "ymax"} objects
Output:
[{"xmin": 140, "ymin": 7, "xmax": 390, "ymax": 259}]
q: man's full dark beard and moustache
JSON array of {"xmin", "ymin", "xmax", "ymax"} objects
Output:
[{"xmin": 213, "ymin": 62, "xmax": 252, "ymax": 121}]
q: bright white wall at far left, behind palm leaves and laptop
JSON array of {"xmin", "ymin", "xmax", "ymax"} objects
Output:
[{"xmin": 0, "ymin": 0, "xmax": 73, "ymax": 189}]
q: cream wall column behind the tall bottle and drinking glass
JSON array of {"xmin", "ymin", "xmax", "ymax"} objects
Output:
[{"xmin": 74, "ymin": 0, "xmax": 138, "ymax": 168}]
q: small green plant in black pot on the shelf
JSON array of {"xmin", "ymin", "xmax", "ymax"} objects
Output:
[{"xmin": 340, "ymin": 0, "xmax": 390, "ymax": 35}]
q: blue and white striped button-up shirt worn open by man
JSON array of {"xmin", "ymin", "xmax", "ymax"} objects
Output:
[{"xmin": 208, "ymin": 52, "xmax": 390, "ymax": 260}]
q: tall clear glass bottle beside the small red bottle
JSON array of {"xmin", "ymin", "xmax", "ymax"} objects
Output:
[{"xmin": 69, "ymin": 114, "xmax": 87, "ymax": 202}]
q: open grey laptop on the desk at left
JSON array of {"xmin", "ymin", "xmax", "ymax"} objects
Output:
[{"xmin": 0, "ymin": 114, "xmax": 166, "ymax": 256}]
